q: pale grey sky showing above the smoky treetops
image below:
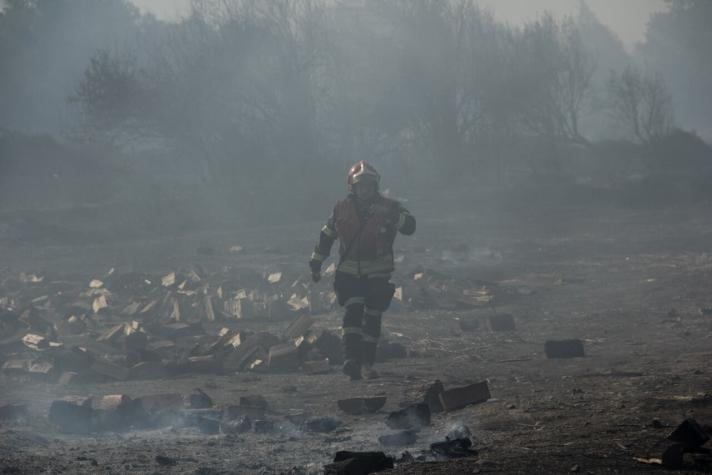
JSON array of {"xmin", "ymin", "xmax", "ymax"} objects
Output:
[{"xmin": 131, "ymin": 0, "xmax": 666, "ymax": 50}]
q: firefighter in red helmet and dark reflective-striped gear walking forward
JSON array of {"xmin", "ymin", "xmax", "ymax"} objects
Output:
[{"xmin": 309, "ymin": 160, "xmax": 415, "ymax": 380}]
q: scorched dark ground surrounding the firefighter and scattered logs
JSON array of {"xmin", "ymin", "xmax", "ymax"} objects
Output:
[{"xmin": 0, "ymin": 206, "xmax": 712, "ymax": 474}]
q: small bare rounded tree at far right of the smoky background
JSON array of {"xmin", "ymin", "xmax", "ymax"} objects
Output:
[{"xmin": 607, "ymin": 65, "xmax": 673, "ymax": 143}]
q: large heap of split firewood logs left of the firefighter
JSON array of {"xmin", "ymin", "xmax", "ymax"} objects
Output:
[{"xmin": 0, "ymin": 270, "xmax": 405, "ymax": 384}]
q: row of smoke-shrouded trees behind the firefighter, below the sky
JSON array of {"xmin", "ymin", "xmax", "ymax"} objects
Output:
[{"xmin": 0, "ymin": 0, "xmax": 709, "ymax": 195}]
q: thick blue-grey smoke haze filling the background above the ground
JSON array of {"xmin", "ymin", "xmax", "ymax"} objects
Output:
[{"xmin": 0, "ymin": 0, "xmax": 712, "ymax": 229}]
